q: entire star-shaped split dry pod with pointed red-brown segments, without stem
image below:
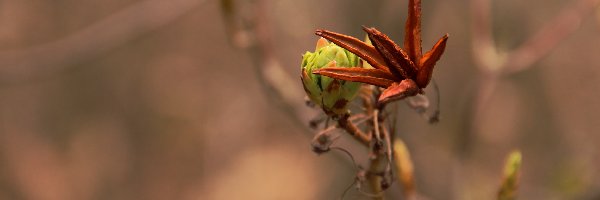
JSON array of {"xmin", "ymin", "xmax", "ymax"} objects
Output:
[{"xmin": 313, "ymin": 0, "xmax": 448, "ymax": 103}]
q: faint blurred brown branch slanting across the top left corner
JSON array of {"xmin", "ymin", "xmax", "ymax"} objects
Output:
[{"xmin": 0, "ymin": 0, "xmax": 205, "ymax": 83}]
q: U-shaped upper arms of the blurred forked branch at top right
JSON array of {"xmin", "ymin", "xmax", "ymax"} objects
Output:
[{"xmin": 471, "ymin": 0, "xmax": 600, "ymax": 74}]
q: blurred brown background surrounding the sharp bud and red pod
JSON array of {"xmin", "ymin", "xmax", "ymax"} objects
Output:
[{"xmin": 0, "ymin": 0, "xmax": 600, "ymax": 200}]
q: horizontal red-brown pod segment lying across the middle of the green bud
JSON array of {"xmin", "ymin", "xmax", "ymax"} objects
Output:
[{"xmin": 313, "ymin": 67, "xmax": 395, "ymax": 88}]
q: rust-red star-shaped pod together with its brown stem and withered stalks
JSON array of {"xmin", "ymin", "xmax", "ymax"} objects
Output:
[{"xmin": 302, "ymin": 0, "xmax": 448, "ymax": 199}]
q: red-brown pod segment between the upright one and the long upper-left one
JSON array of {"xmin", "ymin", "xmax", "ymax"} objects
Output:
[{"xmin": 363, "ymin": 26, "xmax": 416, "ymax": 79}]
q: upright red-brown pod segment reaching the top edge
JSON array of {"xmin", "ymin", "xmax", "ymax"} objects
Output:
[{"xmin": 404, "ymin": 0, "xmax": 422, "ymax": 62}]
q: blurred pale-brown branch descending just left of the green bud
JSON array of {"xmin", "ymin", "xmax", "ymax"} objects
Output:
[{"xmin": 221, "ymin": 0, "xmax": 310, "ymax": 133}]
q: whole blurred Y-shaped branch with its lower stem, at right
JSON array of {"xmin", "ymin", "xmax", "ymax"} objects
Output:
[{"xmin": 462, "ymin": 0, "xmax": 600, "ymax": 198}]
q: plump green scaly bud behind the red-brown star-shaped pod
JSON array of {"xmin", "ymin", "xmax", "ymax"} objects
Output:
[{"xmin": 301, "ymin": 38, "xmax": 361, "ymax": 116}]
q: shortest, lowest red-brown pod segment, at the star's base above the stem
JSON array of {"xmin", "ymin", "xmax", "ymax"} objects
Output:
[{"xmin": 378, "ymin": 79, "xmax": 420, "ymax": 103}]
